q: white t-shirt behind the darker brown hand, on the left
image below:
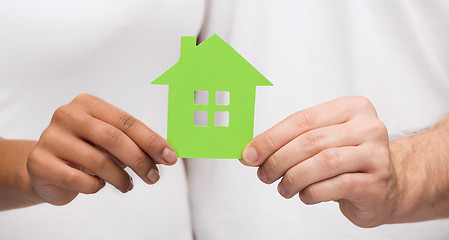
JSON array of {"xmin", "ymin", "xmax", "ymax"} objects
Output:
[{"xmin": 0, "ymin": 0, "xmax": 204, "ymax": 240}]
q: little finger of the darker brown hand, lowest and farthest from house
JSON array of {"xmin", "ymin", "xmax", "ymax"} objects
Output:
[{"xmin": 35, "ymin": 154, "xmax": 105, "ymax": 194}]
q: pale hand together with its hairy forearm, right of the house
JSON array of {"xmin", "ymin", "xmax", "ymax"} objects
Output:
[{"xmin": 241, "ymin": 97, "xmax": 449, "ymax": 227}]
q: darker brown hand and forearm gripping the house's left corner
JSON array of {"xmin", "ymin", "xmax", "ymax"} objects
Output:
[{"xmin": 0, "ymin": 94, "xmax": 177, "ymax": 210}]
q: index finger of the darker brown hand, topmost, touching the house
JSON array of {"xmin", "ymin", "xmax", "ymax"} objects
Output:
[{"xmin": 73, "ymin": 94, "xmax": 178, "ymax": 165}]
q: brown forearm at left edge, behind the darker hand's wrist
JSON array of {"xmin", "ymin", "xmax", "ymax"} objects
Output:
[{"xmin": 0, "ymin": 138, "xmax": 43, "ymax": 211}]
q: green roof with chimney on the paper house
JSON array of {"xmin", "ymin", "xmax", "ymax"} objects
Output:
[{"xmin": 151, "ymin": 34, "xmax": 273, "ymax": 86}]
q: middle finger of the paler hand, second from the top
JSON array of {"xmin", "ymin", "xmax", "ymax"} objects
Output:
[{"xmin": 259, "ymin": 122, "xmax": 364, "ymax": 183}]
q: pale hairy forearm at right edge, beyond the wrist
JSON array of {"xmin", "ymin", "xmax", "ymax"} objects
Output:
[{"xmin": 390, "ymin": 117, "xmax": 449, "ymax": 223}]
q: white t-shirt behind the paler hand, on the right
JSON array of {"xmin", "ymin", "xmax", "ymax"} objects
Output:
[{"xmin": 187, "ymin": 0, "xmax": 449, "ymax": 240}]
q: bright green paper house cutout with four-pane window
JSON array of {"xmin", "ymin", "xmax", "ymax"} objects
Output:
[{"xmin": 152, "ymin": 35, "xmax": 272, "ymax": 159}]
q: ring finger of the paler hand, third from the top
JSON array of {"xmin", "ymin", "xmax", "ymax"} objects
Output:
[{"xmin": 278, "ymin": 147, "xmax": 371, "ymax": 198}]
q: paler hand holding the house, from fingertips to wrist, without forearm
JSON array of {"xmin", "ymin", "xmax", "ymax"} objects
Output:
[{"xmin": 241, "ymin": 97, "xmax": 398, "ymax": 227}]
